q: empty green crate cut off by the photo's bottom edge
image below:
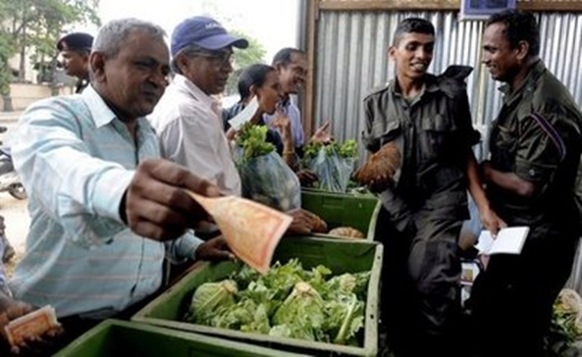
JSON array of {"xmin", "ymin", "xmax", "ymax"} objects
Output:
[{"xmin": 55, "ymin": 320, "xmax": 305, "ymax": 357}]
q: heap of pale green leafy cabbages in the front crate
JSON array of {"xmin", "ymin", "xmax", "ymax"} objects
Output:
[{"xmin": 186, "ymin": 259, "xmax": 370, "ymax": 345}]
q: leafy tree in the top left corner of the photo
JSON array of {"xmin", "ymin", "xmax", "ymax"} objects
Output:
[{"xmin": 0, "ymin": 0, "xmax": 100, "ymax": 107}]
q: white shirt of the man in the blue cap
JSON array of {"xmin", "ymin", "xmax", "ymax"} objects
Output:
[{"xmin": 148, "ymin": 74, "xmax": 241, "ymax": 196}]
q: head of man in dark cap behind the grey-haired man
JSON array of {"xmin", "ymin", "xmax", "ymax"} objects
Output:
[{"xmin": 57, "ymin": 32, "xmax": 93, "ymax": 93}]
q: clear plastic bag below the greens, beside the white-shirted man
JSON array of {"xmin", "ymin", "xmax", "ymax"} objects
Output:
[{"xmin": 234, "ymin": 148, "xmax": 301, "ymax": 212}]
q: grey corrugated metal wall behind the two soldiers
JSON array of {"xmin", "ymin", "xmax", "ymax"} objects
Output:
[{"xmin": 313, "ymin": 11, "xmax": 582, "ymax": 291}]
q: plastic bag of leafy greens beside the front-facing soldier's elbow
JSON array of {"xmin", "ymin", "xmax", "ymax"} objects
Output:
[{"xmin": 304, "ymin": 140, "xmax": 357, "ymax": 192}]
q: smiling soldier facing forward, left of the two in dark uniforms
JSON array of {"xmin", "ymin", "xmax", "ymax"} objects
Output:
[{"xmin": 363, "ymin": 18, "xmax": 500, "ymax": 356}]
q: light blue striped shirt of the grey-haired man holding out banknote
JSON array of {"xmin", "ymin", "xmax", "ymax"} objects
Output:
[{"xmin": 10, "ymin": 86, "xmax": 201, "ymax": 318}]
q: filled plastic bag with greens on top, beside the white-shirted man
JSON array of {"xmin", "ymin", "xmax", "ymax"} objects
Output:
[{"xmin": 233, "ymin": 125, "xmax": 301, "ymax": 212}]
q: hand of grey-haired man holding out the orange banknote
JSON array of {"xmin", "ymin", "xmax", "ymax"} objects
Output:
[{"xmin": 121, "ymin": 159, "xmax": 220, "ymax": 240}]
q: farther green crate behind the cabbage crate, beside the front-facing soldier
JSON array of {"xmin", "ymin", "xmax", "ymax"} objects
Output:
[{"xmin": 301, "ymin": 188, "xmax": 382, "ymax": 241}]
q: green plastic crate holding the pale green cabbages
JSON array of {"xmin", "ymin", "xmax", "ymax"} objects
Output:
[{"xmin": 132, "ymin": 237, "xmax": 383, "ymax": 356}]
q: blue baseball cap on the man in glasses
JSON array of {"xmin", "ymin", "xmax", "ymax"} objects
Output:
[{"xmin": 170, "ymin": 16, "xmax": 249, "ymax": 56}]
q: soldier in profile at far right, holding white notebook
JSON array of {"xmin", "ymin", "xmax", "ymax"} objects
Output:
[{"xmin": 471, "ymin": 10, "xmax": 582, "ymax": 356}]
